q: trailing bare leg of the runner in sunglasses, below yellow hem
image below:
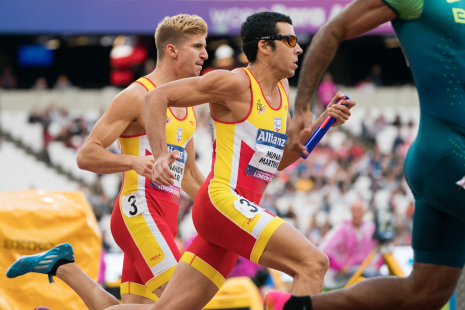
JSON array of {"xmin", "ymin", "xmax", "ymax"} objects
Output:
[{"xmin": 108, "ymin": 262, "xmax": 218, "ymax": 310}]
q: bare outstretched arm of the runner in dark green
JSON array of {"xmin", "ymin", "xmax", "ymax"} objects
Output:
[{"xmin": 289, "ymin": 0, "xmax": 396, "ymax": 151}]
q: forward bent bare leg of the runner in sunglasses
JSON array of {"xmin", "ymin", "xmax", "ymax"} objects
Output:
[{"xmin": 259, "ymin": 223, "xmax": 329, "ymax": 296}]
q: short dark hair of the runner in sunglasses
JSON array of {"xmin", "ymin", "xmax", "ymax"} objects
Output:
[{"xmin": 241, "ymin": 12, "xmax": 292, "ymax": 63}]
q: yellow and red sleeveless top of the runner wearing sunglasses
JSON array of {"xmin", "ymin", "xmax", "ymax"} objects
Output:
[{"xmin": 207, "ymin": 68, "xmax": 289, "ymax": 209}]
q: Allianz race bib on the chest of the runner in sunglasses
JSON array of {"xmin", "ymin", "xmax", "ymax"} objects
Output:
[{"xmin": 245, "ymin": 129, "xmax": 287, "ymax": 183}]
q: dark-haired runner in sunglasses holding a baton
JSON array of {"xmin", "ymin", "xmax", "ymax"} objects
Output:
[{"xmin": 106, "ymin": 12, "xmax": 355, "ymax": 310}]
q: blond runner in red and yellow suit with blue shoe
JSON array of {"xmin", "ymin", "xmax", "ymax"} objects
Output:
[{"xmin": 5, "ymin": 14, "xmax": 208, "ymax": 310}]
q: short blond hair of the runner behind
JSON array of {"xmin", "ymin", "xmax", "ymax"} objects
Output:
[{"xmin": 155, "ymin": 14, "xmax": 208, "ymax": 60}]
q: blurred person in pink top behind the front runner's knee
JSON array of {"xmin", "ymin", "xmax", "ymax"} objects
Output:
[{"xmin": 320, "ymin": 201, "xmax": 382, "ymax": 288}]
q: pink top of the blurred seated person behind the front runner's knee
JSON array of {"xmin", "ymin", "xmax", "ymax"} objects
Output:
[{"xmin": 320, "ymin": 220, "xmax": 383, "ymax": 270}]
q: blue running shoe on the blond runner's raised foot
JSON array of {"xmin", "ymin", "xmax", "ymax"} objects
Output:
[{"xmin": 6, "ymin": 243, "xmax": 74, "ymax": 283}]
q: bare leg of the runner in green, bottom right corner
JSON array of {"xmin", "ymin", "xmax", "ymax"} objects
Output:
[{"xmin": 308, "ymin": 263, "xmax": 462, "ymax": 310}]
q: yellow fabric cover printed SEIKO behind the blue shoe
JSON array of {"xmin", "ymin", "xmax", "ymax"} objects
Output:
[{"xmin": 0, "ymin": 190, "xmax": 102, "ymax": 310}]
